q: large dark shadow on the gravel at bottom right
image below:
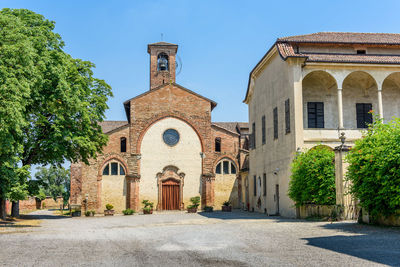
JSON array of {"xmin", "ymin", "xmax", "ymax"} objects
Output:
[{"xmin": 303, "ymin": 223, "xmax": 400, "ymax": 266}]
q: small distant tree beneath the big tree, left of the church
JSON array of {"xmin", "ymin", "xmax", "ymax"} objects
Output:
[{"xmin": 35, "ymin": 166, "xmax": 70, "ymax": 202}]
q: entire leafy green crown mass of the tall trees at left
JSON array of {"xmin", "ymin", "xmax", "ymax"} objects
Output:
[{"xmin": 0, "ymin": 8, "xmax": 112, "ymax": 217}]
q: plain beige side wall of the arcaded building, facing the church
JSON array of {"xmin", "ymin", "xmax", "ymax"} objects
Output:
[{"xmin": 248, "ymin": 52, "xmax": 296, "ymax": 217}]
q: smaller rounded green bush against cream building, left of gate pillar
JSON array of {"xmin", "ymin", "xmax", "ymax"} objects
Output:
[{"xmin": 288, "ymin": 145, "xmax": 336, "ymax": 206}]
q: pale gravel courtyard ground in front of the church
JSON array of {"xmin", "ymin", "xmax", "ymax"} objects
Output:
[{"xmin": 0, "ymin": 211, "xmax": 400, "ymax": 266}]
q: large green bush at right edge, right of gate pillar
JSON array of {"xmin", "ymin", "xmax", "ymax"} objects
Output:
[{"xmin": 346, "ymin": 119, "xmax": 400, "ymax": 219}]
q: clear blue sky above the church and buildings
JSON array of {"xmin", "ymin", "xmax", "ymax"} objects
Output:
[{"xmin": 0, "ymin": 0, "xmax": 400, "ymax": 121}]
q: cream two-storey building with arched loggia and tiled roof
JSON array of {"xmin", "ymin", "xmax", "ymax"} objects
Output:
[{"xmin": 244, "ymin": 32, "xmax": 400, "ymax": 217}]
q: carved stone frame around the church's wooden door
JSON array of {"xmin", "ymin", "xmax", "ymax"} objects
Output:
[{"xmin": 157, "ymin": 165, "xmax": 185, "ymax": 210}]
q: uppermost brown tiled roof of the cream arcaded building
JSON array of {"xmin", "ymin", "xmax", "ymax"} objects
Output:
[{"xmin": 277, "ymin": 32, "xmax": 400, "ymax": 44}]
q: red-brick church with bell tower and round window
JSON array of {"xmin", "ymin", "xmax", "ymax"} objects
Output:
[{"xmin": 71, "ymin": 42, "xmax": 248, "ymax": 212}]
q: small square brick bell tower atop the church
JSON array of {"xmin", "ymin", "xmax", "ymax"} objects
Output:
[{"xmin": 147, "ymin": 42, "xmax": 178, "ymax": 90}]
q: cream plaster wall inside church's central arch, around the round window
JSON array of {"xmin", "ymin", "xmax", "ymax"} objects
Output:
[{"xmin": 139, "ymin": 118, "xmax": 201, "ymax": 207}]
